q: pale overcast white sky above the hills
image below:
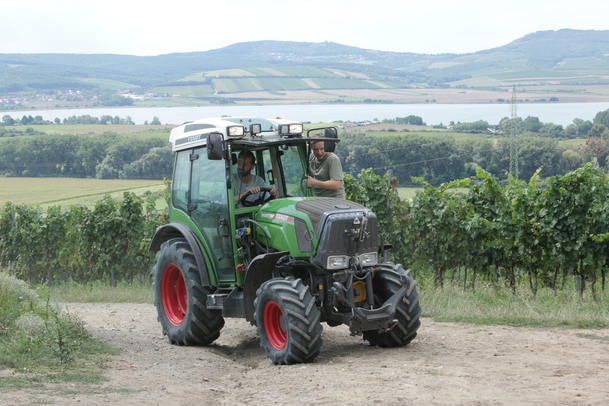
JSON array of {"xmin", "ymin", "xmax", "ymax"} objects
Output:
[{"xmin": 0, "ymin": 0, "xmax": 609, "ymax": 55}]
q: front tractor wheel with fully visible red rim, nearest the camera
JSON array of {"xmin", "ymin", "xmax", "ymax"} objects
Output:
[{"xmin": 254, "ymin": 278, "xmax": 323, "ymax": 364}]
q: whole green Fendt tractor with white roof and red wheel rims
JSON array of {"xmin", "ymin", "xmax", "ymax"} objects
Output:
[{"xmin": 150, "ymin": 117, "xmax": 421, "ymax": 364}]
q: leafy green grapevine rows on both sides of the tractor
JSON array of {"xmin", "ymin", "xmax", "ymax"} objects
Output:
[{"xmin": 0, "ymin": 164, "xmax": 609, "ymax": 297}]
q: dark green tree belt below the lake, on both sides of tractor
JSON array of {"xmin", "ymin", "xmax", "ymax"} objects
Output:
[{"xmin": 0, "ymin": 110, "xmax": 609, "ymax": 185}]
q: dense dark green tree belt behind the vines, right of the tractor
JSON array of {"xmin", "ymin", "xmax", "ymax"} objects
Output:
[{"xmin": 336, "ymin": 110, "xmax": 609, "ymax": 185}]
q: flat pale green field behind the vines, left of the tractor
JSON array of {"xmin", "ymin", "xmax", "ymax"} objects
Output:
[{"xmin": 0, "ymin": 178, "xmax": 165, "ymax": 208}]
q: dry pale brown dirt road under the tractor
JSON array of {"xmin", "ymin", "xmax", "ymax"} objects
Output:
[{"xmin": 0, "ymin": 303, "xmax": 609, "ymax": 406}]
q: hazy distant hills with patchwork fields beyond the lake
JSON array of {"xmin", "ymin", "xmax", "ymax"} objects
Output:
[{"xmin": 0, "ymin": 29, "xmax": 609, "ymax": 101}]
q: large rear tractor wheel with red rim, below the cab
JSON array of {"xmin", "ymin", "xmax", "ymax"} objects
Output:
[{"xmin": 154, "ymin": 238, "xmax": 224, "ymax": 345}]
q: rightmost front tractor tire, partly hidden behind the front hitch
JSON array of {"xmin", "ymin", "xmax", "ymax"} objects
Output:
[{"xmin": 363, "ymin": 263, "xmax": 421, "ymax": 347}]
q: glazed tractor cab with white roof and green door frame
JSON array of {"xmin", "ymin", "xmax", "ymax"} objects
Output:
[{"xmin": 154, "ymin": 117, "xmax": 338, "ymax": 285}]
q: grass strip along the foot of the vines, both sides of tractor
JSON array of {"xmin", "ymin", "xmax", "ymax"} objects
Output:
[{"xmin": 49, "ymin": 282, "xmax": 609, "ymax": 329}]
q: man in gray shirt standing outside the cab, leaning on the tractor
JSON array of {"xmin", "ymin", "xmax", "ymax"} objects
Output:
[{"xmin": 305, "ymin": 141, "xmax": 345, "ymax": 199}]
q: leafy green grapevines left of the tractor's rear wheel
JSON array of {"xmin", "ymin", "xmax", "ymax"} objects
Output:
[{"xmin": 0, "ymin": 192, "xmax": 166, "ymax": 286}]
